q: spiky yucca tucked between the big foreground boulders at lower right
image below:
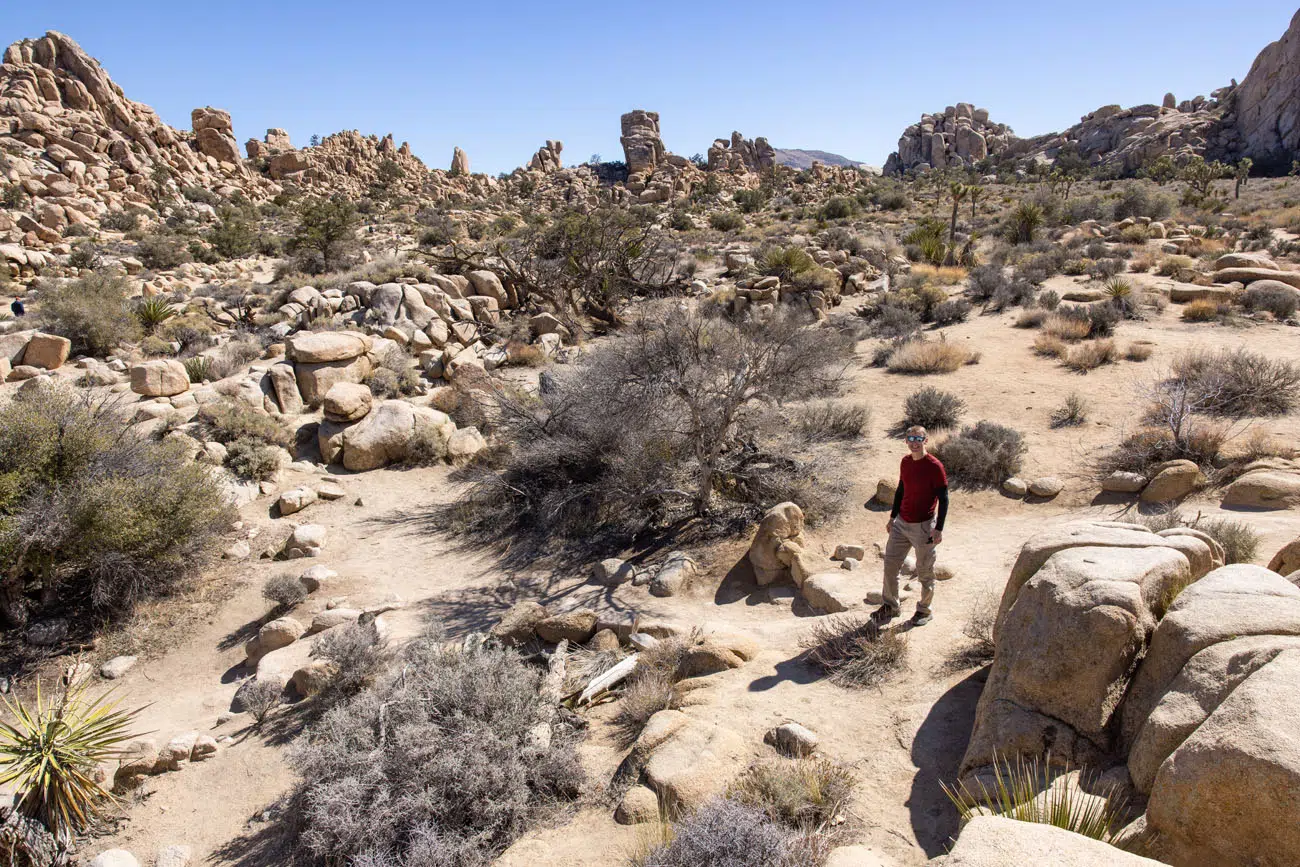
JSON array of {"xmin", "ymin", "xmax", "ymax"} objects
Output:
[{"xmin": 940, "ymin": 755, "xmax": 1140, "ymax": 849}]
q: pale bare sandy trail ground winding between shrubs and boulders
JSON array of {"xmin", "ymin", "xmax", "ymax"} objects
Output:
[{"xmin": 87, "ymin": 295, "xmax": 1300, "ymax": 867}]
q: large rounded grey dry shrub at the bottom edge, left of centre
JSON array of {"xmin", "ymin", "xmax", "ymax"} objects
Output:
[{"xmin": 290, "ymin": 633, "xmax": 582, "ymax": 867}]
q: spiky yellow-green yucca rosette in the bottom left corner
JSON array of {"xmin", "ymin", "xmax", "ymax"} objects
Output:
[{"xmin": 0, "ymin": 680, "xmax": 144, "ymax": 842}]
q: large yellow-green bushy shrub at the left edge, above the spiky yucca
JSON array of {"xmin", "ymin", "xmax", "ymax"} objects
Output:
[{"xmin": 0, "ymin": 387, "xmax": 230, "ymax": 623}]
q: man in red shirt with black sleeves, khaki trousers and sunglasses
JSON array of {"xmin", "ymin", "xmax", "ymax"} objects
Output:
[{"xmin": 875, "ymin": 425, "xmax": 948, "ymax": 627}]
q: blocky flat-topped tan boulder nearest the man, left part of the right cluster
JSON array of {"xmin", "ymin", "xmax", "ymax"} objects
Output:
[{"xmin": 962, "ymin": 523, "xmax": 1223, "ymax": 775}]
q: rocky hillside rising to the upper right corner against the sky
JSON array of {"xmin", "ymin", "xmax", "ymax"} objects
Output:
[{"xmin": 885, "ymin": 12, "xmax": 1300, "ymax": 174}]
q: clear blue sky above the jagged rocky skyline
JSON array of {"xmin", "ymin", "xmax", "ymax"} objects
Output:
[{"xmin": 0, "ymin": 0, "xmax": 1296, "ymax": 173}]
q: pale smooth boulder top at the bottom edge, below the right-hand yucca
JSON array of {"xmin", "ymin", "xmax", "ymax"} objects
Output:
[{"xmin": 930, "ymin": 816, "xmax": 1160, "ymax": 867}]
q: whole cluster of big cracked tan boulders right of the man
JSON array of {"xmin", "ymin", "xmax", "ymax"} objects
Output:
[{"xmin": 961, "ymin": 523, "xmax": 1300, "ymax": 867}]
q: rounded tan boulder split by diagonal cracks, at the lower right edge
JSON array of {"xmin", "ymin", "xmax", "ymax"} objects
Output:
[{"xmin": 1123, "ymin": 565, "xmax": 1300, "ymax": 867}]
